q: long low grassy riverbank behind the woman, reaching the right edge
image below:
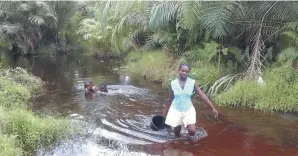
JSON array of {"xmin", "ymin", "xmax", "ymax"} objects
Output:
[{"xmin": 125, "ymin": 50, "xmax": 298, "ymax": 112}]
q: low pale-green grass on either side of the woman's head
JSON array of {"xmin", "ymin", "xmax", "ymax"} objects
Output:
[{"xmin": 125, "ymin": 49, "xmax": 220, "ymax": 87}]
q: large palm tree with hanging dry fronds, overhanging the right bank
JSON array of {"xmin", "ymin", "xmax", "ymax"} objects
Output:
[{"xmin": 150, "ymin": 1, "xmax": 298, "ymax": 78}]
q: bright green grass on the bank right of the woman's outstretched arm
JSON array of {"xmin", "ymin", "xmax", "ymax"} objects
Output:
[{"xmin": 215, "ymin": 66, "xmax": 298, "ymax": 112}]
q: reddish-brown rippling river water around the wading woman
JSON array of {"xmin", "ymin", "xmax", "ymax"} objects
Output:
[{"xmin": 1, "ymin": 53, "xmax": 298, "ymax": 156}]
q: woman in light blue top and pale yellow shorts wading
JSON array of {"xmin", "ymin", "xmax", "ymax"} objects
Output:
[{"xmin": 163, "ymin": 64, "xmax": 218, "ymax": 137}]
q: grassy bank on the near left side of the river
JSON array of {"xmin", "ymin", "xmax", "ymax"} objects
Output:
[{"xmin": 0, "ymin": 68, "xmax": 74, "ymax": 156}]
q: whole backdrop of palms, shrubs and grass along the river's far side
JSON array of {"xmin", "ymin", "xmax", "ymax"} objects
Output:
[{"xmin": 0, "ymin": 1, "xmax": 298, "ymax": 111}]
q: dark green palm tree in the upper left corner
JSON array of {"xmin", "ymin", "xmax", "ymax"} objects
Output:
[{"xmin": 0, "ymin": 1, "xmax": 58, "ymax": 54}]
